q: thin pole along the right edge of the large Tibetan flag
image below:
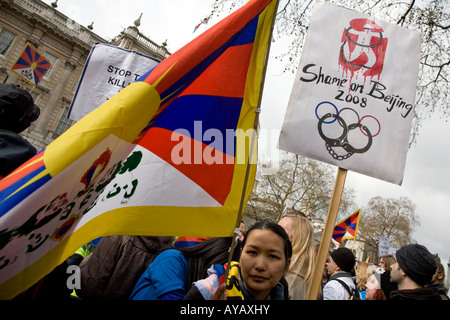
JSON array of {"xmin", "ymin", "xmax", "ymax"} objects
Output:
[{"xmin": 225, "ymin": 0, "xmax": 279, "ymax": 281}]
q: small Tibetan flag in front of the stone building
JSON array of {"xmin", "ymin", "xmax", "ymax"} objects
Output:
[{"xmin": 11, "ymin": 42, "xmax": 52, "ymax": 86}]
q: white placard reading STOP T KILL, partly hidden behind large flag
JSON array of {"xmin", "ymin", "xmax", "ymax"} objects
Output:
[{"xmin": 69, "ymin": 43, "xmax": 160, "ymax": 121}]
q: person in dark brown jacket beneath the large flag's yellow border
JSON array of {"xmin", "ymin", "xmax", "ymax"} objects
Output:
[{"xmin": 75, "ymin": 236, "xmax": 174, "ymax": 300}]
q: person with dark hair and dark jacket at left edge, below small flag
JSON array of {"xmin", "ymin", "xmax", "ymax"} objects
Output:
[{"xmin": 0, "ymin": 83, "xmax": 40, "ymax": 180}]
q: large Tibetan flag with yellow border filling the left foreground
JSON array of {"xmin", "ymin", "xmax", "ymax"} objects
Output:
[{"xmin": 0, "ymin": 0, "xmax": 276, "ymax": 298}]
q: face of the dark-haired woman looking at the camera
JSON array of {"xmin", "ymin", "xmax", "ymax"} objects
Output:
[{"xmin": 239, "ymin": 229, "xmax": 290, "ymax": 300}]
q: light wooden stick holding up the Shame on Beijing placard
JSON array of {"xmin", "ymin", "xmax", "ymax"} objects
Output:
[{"xmin": 306, "ymin": 168, "xmax": 347, "ymax": 300}]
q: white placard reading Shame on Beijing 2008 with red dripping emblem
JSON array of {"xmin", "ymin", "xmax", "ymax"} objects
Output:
[{"xmin": 279, "ymin": 3, "xmax": 420, "ymax": 184}]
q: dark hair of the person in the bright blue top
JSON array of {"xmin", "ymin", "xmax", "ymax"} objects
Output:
[{"xmin": 178, "ymin": 237, "xmax": 241, "ymax": 292}]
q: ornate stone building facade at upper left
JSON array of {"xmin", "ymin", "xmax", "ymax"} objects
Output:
[{"xmin": 0, "ymin": 0, "xmax": 170, "ymax": 150}]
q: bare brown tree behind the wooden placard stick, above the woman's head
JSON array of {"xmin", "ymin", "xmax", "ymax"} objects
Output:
[{"xmin": 246, "ymin": 153, "xmax": 355, "ymax": 221}]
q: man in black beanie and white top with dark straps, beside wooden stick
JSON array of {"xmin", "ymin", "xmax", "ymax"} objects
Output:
[{"xmin": 323, "ymin": 248, "xmax": 359, "ymax": 300}]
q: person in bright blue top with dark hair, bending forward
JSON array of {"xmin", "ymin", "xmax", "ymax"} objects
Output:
[{"xmin": 129, "ymin": 237, "xmax": 239, "ymax": 300}]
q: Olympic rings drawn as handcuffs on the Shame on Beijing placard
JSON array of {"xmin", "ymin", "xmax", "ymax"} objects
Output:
[{"xmin": 315, "ymin": 101, "xmax": 381, "ymax": 160}]
